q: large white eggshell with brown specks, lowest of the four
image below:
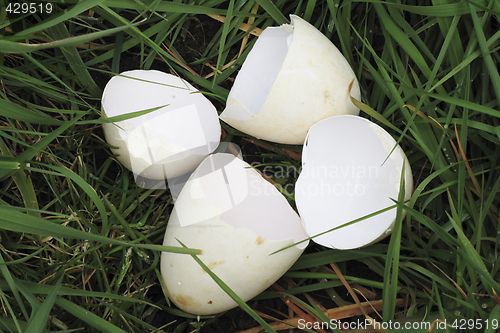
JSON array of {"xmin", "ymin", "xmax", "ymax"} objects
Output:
[{"xmin": 161, "ymin": 154, "xmax": 307, "ymax": 315}]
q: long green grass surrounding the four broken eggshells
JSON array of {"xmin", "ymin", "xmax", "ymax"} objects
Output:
[{"xmin": 0, "ymin": 0, "xmax": 500, "ymax": 333}]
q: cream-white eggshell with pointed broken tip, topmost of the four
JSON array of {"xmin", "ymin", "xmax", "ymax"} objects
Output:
[{"xmin": 220, "ymin": 15, "xmax": 360, "ymax": 144}]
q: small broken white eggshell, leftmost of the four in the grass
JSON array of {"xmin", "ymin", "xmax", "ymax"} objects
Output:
[{"xmin": 102, "ymin": 70, "xmax": 221, "ymax": 179}]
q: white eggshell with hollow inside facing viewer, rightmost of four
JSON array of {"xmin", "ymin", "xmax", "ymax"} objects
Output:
[{"xmin": 295, "ymin": 116, "xmax": 413, "ymax": 249}]
